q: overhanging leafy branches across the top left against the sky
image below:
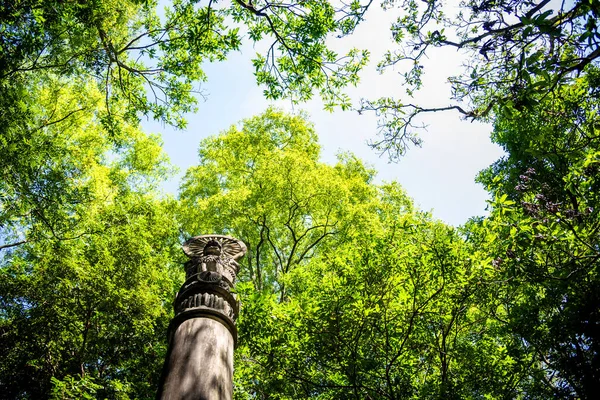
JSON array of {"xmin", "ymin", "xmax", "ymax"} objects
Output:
[{"xmin": 0, "ymin": 0, "xmax": 367, "ymax": 126}]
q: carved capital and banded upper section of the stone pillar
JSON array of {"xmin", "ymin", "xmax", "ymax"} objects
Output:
[{"xmin": 172, "ymin": 235, "xmax": 247, "ymax": 341}]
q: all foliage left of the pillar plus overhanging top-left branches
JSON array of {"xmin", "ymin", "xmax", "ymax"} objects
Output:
[{"xmin": 0, "ymin": 0, "xmax": 367, "ymax": 399}]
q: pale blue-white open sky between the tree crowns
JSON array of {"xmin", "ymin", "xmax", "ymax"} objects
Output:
[{"xmin": 143, "ymin": 2, "xmax": 503, "ymax": 226}]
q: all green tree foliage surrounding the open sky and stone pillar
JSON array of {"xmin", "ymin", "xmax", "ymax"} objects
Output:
[{"xmin": 0, "ymin": 0, "xmax": 600, "ymax": 399}]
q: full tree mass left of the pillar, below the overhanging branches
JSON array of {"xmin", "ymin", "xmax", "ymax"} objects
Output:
[{"xmin": 0, "ymin": 72, "xmax": 179, "ymax": 399}]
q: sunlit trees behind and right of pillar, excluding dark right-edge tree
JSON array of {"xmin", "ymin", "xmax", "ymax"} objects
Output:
[{"xmin": 175, "ymin": 109, "xmax": 529, "ymax": 399}]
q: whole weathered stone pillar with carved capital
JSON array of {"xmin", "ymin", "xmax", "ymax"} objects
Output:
[{"xmin": 157, "ymin": 235, "xmax": 246, "ymax": 400}]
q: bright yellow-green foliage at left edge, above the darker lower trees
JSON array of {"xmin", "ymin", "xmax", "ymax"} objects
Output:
[{"xmin": 0, "ymin": 75, "xmax": 172, "ymax": 247}]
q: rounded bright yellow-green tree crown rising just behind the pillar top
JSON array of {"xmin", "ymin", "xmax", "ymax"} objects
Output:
[{"xmin": 180, "ymin": 109, "xmax": 380, "ymax": 296}]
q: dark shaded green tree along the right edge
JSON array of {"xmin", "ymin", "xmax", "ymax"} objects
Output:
[{"xmin": 480, "ymin": 68, "xmax": 600, "ymax": 399}]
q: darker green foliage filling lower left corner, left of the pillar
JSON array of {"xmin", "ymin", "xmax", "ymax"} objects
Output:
[{"xmin": 0, "ymin": 194, "xmax": 180, "ymax": 398}]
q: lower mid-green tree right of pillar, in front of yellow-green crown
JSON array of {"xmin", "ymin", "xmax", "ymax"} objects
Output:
[{"xmin": 236, "ymin": 190, "xmax": 521, "ymax": 399}]
